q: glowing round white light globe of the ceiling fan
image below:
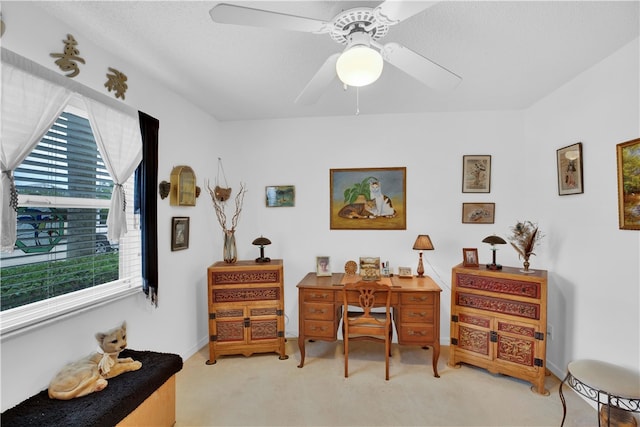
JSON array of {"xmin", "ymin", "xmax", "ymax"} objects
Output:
[{"xmin": 336, "ymin": 46, "xmax": 384, "ymax": 87}]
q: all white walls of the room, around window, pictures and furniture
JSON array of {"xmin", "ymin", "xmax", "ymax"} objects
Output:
[{"xmin": 1, "ymin": 2, "xmax": 640, "ymax": 410}]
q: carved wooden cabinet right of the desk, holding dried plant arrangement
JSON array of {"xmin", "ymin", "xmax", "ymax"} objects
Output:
[{"xmin": 449, "ymin": 265, "xmax": 549, "ymax": 395}]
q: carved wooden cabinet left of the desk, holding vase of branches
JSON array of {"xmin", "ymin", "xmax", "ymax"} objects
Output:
[{"xmin": 207, "ymin": 259, "xmax": 288, "ymax": 365}]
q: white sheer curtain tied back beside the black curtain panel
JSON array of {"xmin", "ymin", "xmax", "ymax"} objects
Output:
[{"xmin": 84, "ymin": 98, "xmax": 142, "ymax": 241}]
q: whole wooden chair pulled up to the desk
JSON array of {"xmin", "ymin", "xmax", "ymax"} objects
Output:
[{"xmin": 342, "ymin": 281, "xmax": 392, "ymax": 380}]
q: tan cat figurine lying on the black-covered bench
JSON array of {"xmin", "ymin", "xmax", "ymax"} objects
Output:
[{"xmin": 49, "ymin": 322, "xmax": 142, "ymax": 400}]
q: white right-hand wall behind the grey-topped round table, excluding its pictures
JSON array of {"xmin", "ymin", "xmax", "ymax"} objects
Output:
[{"xmin": 524, "ymin": 39, "xmax": 640, "ymax": 372}]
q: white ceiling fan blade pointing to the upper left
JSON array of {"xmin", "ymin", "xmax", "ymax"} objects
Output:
[{"xmin": 209, "ymin": 3, "xmax": 331, "ymax": 33}]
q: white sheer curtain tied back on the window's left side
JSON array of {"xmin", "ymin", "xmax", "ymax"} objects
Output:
[{"xmin": 0, "ymin": 62, "xmax": 72, "ymax": 252}]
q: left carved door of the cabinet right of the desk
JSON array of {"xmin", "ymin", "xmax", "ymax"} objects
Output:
[{"xmin": 452, "ymin": 313, "xmax": 495, "ymax": 360}]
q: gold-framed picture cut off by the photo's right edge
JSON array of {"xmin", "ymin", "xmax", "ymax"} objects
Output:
[{"xmin": 616, "ymin": 138, "xmax": 640, "ymax": 230}]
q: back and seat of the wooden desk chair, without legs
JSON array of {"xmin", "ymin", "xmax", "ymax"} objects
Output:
[{"xmin": 343, "ymin": 281, "xmax": 391, "ymax": 336}]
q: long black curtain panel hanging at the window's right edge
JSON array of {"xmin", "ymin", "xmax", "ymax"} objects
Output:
[{"xmin": 134, "ymin": 111, "xmax": 160, "ymax": 306}]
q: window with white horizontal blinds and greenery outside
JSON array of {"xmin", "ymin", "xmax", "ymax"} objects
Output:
[{"xmin": 0, "ymin": 106, "xmax": 141, "ymax": 333}]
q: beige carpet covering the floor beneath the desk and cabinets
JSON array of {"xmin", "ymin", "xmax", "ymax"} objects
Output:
[{"xmin": 176, "ymin": 339, "xmax": 598, "ymax": 427}]
